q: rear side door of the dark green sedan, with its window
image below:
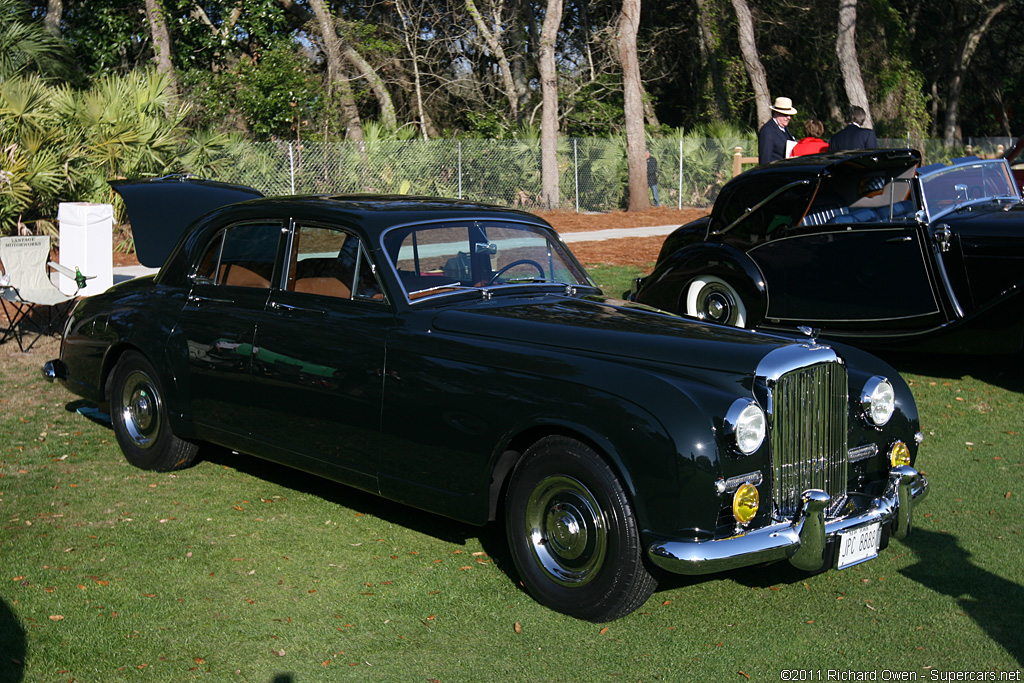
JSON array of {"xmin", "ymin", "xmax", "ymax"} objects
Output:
[{"xmin": 177, "ymin": 221, "xmax": 283, "ymax": 443}]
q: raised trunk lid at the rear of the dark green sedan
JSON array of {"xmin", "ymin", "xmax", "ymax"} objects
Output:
[{"xmin": 110, "ymin": 175, "xmax": 263, "ymax": 268}]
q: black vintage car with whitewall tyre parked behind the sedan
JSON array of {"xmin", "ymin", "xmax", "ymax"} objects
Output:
[{"xmin": 630, "ymin": 150, "xmax": 1024, "ymax": 353}]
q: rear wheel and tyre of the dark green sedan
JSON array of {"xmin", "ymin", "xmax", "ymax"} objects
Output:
[{"xmin": 111, "ymin": 351, "xmax": 199, "ymax": 472}]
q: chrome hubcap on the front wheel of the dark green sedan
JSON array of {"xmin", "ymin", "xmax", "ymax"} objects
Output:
[{"xmin": 524, "ymin": 476, "xmax": 607, "ymax": 586}]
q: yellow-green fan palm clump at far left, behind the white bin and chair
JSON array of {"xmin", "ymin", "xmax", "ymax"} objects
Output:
[{"xmin": 0, "ymin": 66, "xmax": 231, "ymax": 236}]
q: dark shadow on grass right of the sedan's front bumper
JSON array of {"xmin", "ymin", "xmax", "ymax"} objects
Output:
[{"xmin": 900, "ymin": 528, "xmax": 1024, "ymax": 665}]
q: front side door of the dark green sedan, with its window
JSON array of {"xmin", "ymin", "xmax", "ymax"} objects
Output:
[{"xmin": 245, "ymin": 222, "xmax": 394, "ymax": 492}]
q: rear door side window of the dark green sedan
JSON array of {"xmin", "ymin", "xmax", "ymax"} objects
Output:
[{"xmin": 196, "ymin": 223, "xmax": 282, "ymax": 289}]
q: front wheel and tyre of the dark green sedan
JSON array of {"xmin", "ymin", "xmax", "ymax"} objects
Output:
[{"xmin": 505, "ymin": 436, "xmax": 656, "ymax": 622}]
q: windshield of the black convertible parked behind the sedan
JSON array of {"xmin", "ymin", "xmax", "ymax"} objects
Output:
[{"xmin": 921, "ymin": 159, "xmax": 1018, "ymax": 218}]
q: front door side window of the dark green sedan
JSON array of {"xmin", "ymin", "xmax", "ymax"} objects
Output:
[{"xmin": 288, "ymin": 225, "xmax": 383, "ymax": 299}]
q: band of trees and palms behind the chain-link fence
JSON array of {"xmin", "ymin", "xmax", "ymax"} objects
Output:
[{"xmin": 0, "ymin": 0, "xmax": 1024, "ymax": 229}]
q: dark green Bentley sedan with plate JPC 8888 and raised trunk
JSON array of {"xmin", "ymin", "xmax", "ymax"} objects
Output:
[{"xmin": 44, "ymin": 181, "xmax": 928, "ymax": 622}]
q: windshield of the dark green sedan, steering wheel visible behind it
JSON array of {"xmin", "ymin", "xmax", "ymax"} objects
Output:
[{"xmin": 384, "ymin": 221, "xmax": 593, "ymax": 301}]
